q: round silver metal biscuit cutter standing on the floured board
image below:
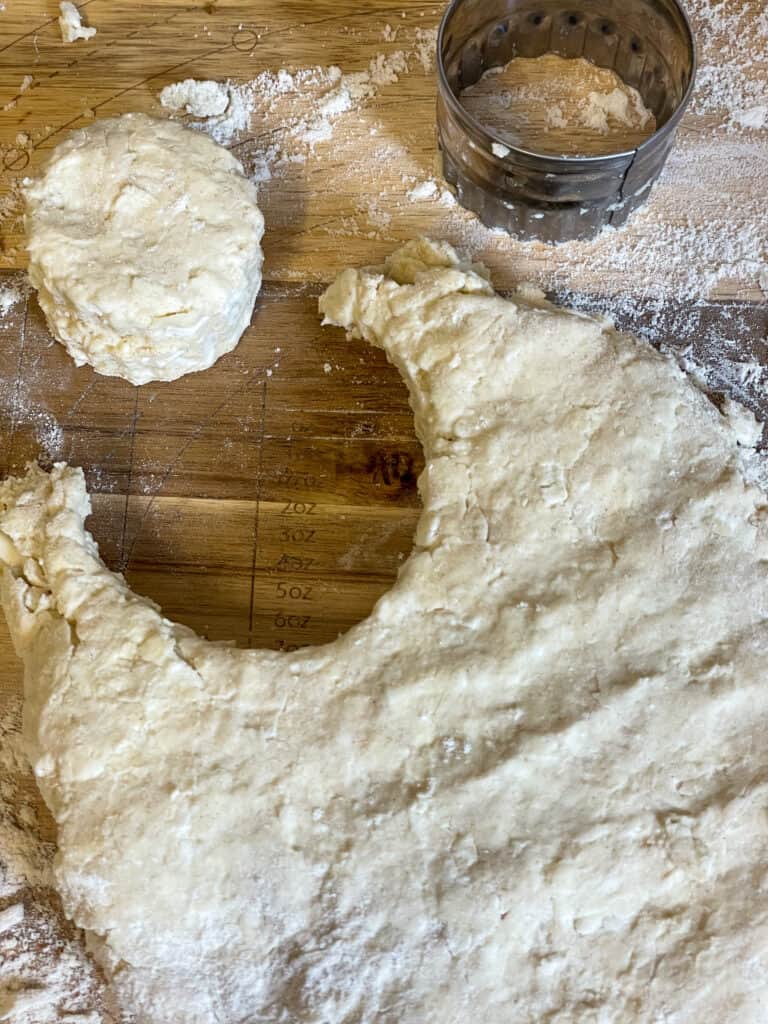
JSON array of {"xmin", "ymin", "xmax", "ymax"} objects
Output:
[{"xmin": 437, "ymin": 0, "xmax": 696, "ymax": 243}]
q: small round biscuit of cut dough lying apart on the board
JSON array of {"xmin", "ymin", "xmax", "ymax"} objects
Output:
[{"xmin": 26, "ymin": 114, "xmax": 264, "ymax": 384}]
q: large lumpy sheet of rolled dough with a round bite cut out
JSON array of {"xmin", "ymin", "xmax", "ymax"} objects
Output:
[{"xmin": 0, "ymin": 242, "xmax": 768, "ymax": 1024}]
